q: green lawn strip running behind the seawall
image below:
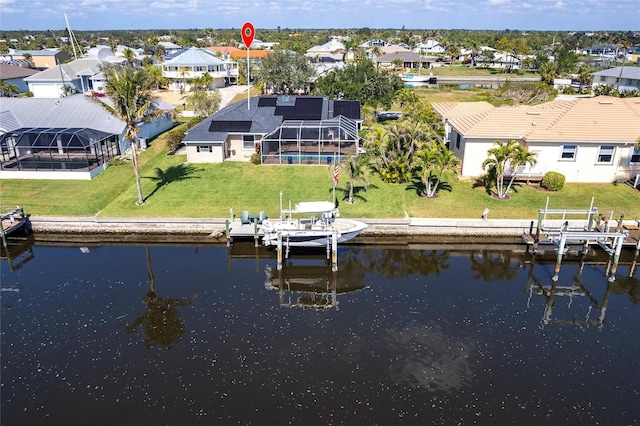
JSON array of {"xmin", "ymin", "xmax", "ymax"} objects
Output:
[{"xmin": 0, "ymin": 141, "xmax": 640, "ymax": 219}]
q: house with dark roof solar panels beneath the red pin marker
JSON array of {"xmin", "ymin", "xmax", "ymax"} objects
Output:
[{"xmin": 183, "ymin": 96, "xmax": 362, "ymax": 165}]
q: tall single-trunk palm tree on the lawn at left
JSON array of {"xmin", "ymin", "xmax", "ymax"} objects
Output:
[{"xmin": 96, "ymin": 66, "xmax": 166, "ymax": 205}]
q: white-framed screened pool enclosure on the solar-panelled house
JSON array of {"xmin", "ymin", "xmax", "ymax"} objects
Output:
[{"xmin": 260, "ymin": 116, "xmax": 359, "ymax": 165}]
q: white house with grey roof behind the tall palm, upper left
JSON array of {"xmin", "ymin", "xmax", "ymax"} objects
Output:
[{"xmin": 25, "ymin": 46, "xmax": 124, "ymax": 98}]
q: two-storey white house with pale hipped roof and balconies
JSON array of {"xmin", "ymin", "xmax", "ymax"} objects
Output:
[{"xmin": 159, "ymin": 47, "xmax": 238, "ymax": 92}]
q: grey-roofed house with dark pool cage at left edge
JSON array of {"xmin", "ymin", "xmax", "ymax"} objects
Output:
[{"xmin": 0, "ymin": 95, "xmax": 173, "ymax": 180}]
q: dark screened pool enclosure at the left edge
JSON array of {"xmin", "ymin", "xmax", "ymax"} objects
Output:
[{"xmin": 0, "ymin": 128, "xmax": 120, "ymax": 171}]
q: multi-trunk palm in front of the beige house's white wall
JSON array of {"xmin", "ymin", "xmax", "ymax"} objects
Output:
[{"xmin": 482, "ymin": 140, "xmax": 536, "ymax": 199}]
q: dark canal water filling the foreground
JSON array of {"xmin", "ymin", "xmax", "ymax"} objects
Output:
[{"xmin": 0, "ymin": 238, "xmax": 640, "ymax": 426}]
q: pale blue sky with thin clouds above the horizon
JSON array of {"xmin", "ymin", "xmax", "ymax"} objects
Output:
[{"xmin": 0, "ymin": 0, "xmax": 640, "ymax": 31}]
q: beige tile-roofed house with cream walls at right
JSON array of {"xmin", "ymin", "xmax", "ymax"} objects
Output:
[{"xmin": 433, "ymin": 96, "xmax": 640, "ymax": 183}]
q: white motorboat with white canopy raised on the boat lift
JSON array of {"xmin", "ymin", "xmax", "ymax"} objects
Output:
[{"xmin": 260, "ymin": 201, "xmax": 368, "ymax": 247}]
